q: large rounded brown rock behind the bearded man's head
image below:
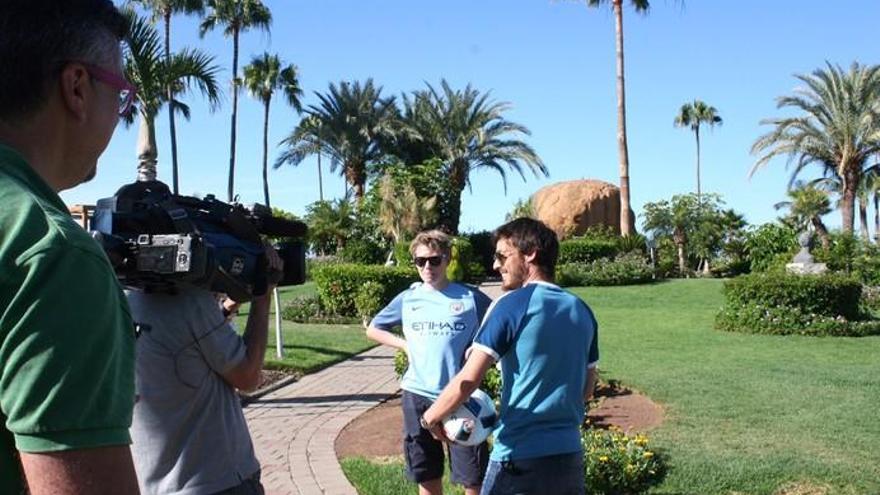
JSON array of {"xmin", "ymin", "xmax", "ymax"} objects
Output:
[{"xmin": 532, "ymin": 179, "xmax": 620, "ymax": 239}]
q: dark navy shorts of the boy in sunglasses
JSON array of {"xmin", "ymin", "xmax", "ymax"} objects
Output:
[{"xmin": 401, "ymin": 390, "xmax": 489, "ymax": 487}]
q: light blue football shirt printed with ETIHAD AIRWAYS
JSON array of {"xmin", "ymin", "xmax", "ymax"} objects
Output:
[{"xmin": 371, "ymin": 283, "xmax": 491, "ymax": 399}]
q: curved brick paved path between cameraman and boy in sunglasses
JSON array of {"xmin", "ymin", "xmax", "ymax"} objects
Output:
[{"xmin": 244, "ymin": 284, "xmax": 501, "ymax": 495}]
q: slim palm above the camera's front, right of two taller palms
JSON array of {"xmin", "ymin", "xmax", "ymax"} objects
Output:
[{"xmin": 244, "ymin": 53, "xmax": 303, "ymax": 206}]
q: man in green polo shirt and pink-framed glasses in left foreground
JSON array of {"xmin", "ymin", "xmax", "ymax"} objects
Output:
[{"xmin": 0, "ymin": 0, "xmax": 137, "ymax": 494}]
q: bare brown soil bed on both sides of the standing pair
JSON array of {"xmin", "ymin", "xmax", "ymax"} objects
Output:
[{"xmin": 336, "ymin": 383, "xmax": 663, "ymax": 458}]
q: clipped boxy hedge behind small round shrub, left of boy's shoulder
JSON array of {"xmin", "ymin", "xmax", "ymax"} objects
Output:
[{"xmin": 312, "ymin": 264, "xmax": 418, "ymax": 316}]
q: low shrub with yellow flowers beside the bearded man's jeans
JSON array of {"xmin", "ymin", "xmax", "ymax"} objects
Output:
[{"xmin": 581, "ymin": 428, "xmax": 667, "ymax": 495}]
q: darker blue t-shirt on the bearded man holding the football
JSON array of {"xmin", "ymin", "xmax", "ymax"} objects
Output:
[{"xmin": 474, "ymin": 282, "xmax": 599, "ymax": 461}]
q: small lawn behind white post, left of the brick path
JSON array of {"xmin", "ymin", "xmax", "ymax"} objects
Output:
[{"xmin": 235, "ymin": 282, "xmax": 376, "ymax": 373}]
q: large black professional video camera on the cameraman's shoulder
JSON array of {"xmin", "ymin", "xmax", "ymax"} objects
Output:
[{"xmin": 92, "ymin": 181, "xmax": 307, "ymax": 302}]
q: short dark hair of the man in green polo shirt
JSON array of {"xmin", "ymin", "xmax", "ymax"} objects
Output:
[{"xmin": 0, "ymin": 0, "xmax": 128, "ymax": 121}]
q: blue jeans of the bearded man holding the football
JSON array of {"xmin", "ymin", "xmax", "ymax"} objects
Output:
[{"xmin": 480, "ymin": 452, "xmax": 586, "ymax": 495}]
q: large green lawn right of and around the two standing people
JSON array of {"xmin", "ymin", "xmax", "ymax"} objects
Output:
[{"xmin": 343, "ymin": 280, "xmax": 880, "ymax": 495}]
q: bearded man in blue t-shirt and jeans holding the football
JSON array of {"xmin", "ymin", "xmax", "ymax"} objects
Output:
[{"xmin": 421, "ymin": 218, "xmax": 599, "ymax": 495}]
